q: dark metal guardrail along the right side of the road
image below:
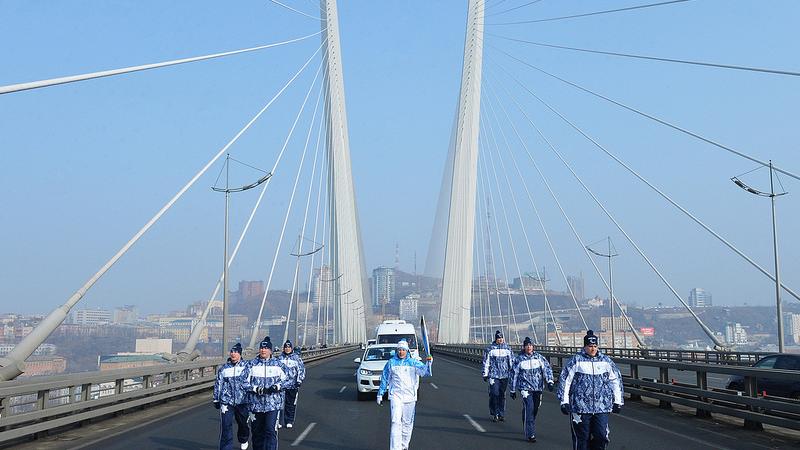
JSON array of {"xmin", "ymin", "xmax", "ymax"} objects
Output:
[{"xmin": 432, "ymin": 345, "xmax": 800, "ymax": 430}]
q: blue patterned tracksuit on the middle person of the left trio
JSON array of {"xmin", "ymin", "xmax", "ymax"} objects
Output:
[{"xmin": 250, "ymin": 356, "xmax": 289, "ymax": 450}]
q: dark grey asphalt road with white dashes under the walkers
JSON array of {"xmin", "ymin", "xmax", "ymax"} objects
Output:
[{"xmin": 79, "ymin": 352, "xmax": 800, "ymax": 450}]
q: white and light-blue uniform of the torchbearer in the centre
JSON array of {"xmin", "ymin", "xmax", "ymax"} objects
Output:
[{"xmin": 378, "ymin": 340, "xmax": 432, "ymax": 450}]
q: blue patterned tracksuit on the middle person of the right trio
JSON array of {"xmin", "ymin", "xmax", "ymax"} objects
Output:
[{"xmin": 511, "ymin": 351, "xmax": 553, "ymax": 438}]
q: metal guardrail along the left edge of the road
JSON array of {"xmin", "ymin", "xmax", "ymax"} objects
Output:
[{"xmin": 0, "ymin": 345, "xmax": 358, "ymax": 444}]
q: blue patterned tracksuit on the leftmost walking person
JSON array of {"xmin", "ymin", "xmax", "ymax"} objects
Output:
[{"xmin": 214, "ymin": 359, "xmax": 250, "ymax": 450}]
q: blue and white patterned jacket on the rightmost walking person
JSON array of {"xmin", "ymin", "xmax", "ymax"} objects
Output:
[{"xmin": 558, "ymin": 351, "xmax": 623, "ymax": 414}]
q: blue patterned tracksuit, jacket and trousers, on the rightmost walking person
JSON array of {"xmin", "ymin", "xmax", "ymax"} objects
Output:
[{"xmin": 558, "ymin": 351, "xmax": 623, "ymax": 450}]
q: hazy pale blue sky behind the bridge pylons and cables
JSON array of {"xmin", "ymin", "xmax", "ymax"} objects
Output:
[{"xmin": 0, "ymin": 0, "xmax": 800, "ymax": 312}]
